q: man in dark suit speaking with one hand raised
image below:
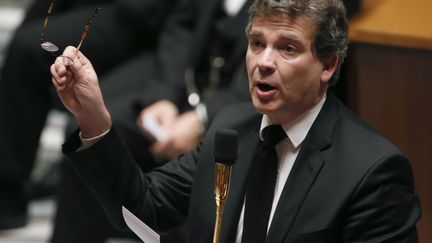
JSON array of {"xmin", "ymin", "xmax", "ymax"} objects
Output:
[{"xmin": 51, "ymin": 0, "xmax": 420, "ymax": 243}]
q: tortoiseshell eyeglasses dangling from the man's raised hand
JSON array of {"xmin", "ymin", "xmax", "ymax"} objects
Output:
[{"xmin": 40, "ymin": 0, "xmax": 101, "ymax": 54}]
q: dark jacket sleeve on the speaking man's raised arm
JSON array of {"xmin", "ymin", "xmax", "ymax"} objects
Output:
[{"xmin": 63, "ymin": 127, "xmax": 198, "ymax": 231}]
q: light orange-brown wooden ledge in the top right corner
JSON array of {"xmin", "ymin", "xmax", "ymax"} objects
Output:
[{"xmin": 350, "ymin": 0, "xmax": 432, "ymax": 49}]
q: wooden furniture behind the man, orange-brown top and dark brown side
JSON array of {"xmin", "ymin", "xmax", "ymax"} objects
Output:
[{"xmin": 345, "ymin": 0, "xmax": 432, "ymax": 243}]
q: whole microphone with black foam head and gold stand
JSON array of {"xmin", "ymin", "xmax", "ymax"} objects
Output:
[{"xmin": 213, "ymin": 129, "xmax": 238, "ymax": 243}]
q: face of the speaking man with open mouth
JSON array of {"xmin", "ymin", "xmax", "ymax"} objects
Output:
[{"xmin": 246, "ymin": 15, "xmax": 337, "ymax": 123}]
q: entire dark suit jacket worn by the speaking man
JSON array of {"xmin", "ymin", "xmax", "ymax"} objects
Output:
[{"xmin": 64, "ymin": 94, "xmax": 420, "ymax": 243}]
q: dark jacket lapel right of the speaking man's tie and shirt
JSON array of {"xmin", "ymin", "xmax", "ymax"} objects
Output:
[{"xmin": 266, "ymin": 93, "xmax": 337, "ymax": 242}]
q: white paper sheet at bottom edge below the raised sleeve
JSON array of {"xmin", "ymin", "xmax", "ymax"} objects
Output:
[{"xmin": 122, "ymin": 206, "xmax": 160, "ymax": 243}]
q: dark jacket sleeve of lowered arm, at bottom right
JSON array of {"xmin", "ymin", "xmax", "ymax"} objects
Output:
[{"xmin": 344, "ymin": 154, "xmax": 420, "ymax": 243}]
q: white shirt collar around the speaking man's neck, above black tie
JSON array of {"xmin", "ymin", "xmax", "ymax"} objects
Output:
[{"xmin": 259, "ymin": 94, "xmax": 326, "ymax": 148}]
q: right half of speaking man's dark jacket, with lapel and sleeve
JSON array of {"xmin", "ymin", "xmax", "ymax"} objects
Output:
[{"xmin": 269, "ymin": 94, "xmax": 420, "ymax": 242}]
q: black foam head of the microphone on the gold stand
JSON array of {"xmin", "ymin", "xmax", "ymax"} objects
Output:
[{"xmin": 214, "ymin": 129, "xmax": 238, "ymax": 165}]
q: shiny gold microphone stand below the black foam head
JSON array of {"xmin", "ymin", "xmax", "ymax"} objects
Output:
[{"xmin": 213, "ymin": 163, "xmax": 231, "ymax": 243}]
